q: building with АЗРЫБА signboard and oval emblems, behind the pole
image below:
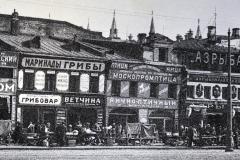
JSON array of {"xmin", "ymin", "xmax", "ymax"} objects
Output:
[{"xmin": 173, "ymin": 26, "xmax": 240, "ymax": 127}]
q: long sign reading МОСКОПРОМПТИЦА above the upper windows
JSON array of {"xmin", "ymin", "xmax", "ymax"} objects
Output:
[{"xmin": 109, "ymin": 70, "xmax": 181, "ymax": 84}]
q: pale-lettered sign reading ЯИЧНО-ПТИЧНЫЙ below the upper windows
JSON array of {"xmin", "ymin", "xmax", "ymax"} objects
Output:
[{"xmin": 107, "ymin": 97, "xmax": 178, "ymax": 109}]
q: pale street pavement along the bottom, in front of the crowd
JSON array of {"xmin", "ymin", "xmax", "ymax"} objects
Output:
[{"xmin": 0, "ymin": 148, "xmax": 240, "ymax": 160}]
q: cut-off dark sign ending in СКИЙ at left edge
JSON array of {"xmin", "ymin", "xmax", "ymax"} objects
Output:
[{"xmin": 0, "ymin": 52, "xmax": 18, "ymax": 68}]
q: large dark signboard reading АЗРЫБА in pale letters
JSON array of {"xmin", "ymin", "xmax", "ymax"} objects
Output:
[{"xmin": 186, "ymin": 51, "xmax": 240, "ymax": 73}]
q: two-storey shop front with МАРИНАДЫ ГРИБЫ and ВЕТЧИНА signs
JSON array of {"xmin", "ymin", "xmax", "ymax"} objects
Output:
[{"xmin": 17, "ymin": 55, "xmax": 105, "ymax": 129}]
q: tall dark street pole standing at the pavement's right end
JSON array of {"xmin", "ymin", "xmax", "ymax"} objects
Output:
[{"xmin": 225, "ymin": 28, "xmax": 233, "ymax": 152}]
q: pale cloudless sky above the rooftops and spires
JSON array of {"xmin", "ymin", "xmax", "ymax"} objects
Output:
[{"xmin": 0, "ymin": 0, "xmax": 240, "ymax": 40}]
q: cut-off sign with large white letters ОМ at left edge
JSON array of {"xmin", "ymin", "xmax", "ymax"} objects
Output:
[{"xmin": 0, "ymin": 78, "xmax": 17, "ymax": 95}]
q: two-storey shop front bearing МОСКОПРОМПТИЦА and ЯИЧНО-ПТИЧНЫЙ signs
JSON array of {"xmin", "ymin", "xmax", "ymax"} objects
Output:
[{"xmin": 106, "ymin": 62, "xmax": 181, "ymax": 133}]
